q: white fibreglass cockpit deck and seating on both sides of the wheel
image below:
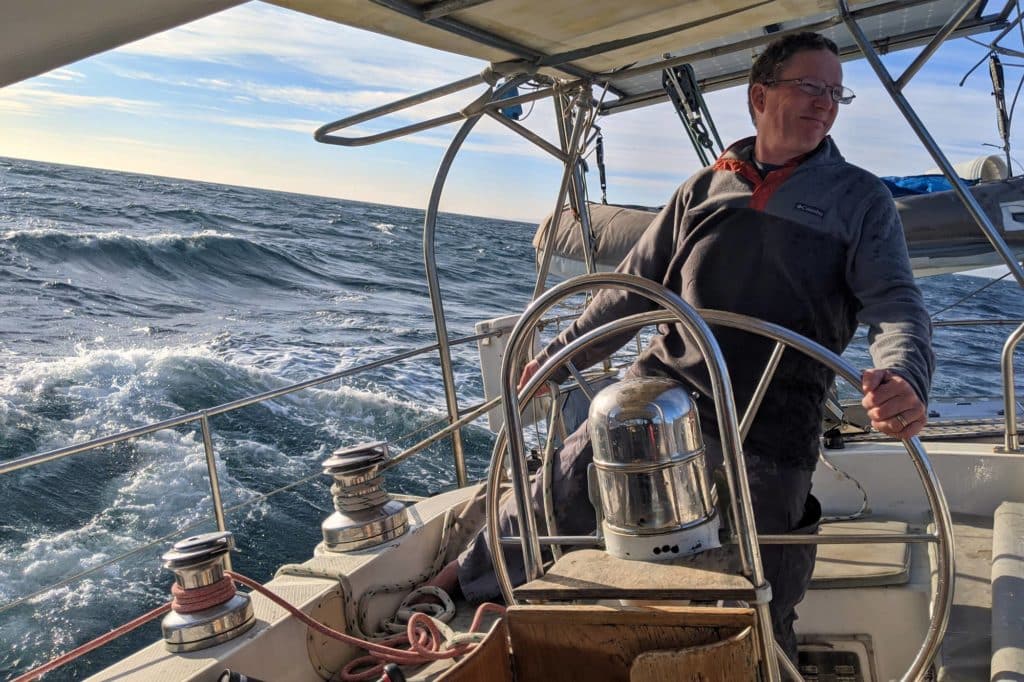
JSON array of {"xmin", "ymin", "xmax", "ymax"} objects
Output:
[{"xmin": 90, "ymin": 442, "xmax": 1024, "ymax": 682}]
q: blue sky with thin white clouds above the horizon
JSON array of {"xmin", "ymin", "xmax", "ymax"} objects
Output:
[{"xmin": 0, "ymin": 2, "xmax": 1021, "ymax": 221}]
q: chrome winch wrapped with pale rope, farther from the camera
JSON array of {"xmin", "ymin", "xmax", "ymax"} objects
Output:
[{"xmin": 321, "ymin": 441, "xmax": 409, "ymax": 552}]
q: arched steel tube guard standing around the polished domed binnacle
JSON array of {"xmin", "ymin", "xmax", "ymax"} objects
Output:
[{"xmin": 487, "ymin": 273, "xmax": 779, "ymax": 682}]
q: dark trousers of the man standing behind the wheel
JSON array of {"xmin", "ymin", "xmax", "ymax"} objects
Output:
[{"xmin": 459, "ymin": 424, "xmax": 821, "ymax": 660}]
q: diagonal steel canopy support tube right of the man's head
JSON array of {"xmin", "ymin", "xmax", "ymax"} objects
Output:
[{"xmin": 838, "ymin": 0, "xmax": 1024, "ymax": 287}]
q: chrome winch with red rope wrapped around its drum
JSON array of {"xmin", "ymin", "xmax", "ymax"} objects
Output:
[{"xmin": 161, "ymin": 531, "xmax": 256, "ymax": 652}]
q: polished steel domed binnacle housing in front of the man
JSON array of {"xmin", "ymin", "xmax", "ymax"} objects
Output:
[{"xmin": 589, "ymin": 377, "xmax": 720, "ymax": 561}]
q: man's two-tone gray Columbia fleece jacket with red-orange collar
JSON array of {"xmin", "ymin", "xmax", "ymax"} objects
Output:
[{"xmin": 539, "ymin": 137, "xmax": 935, "ymax": 469}]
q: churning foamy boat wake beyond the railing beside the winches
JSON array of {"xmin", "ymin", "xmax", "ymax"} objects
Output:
[{"xmin": 0, "ymin": 339, "xmax": 490, "ymax": 673}]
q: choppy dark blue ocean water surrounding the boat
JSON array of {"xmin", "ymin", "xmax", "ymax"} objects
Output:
[{"xmin": 0, "ymin": 158, "xmax": 1024, "ymax": 679}]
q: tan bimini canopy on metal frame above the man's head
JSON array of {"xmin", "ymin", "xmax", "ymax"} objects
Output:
[{"xmin": 264, "ymin": 0, "xmax": 1013, "ymax": 114}]
